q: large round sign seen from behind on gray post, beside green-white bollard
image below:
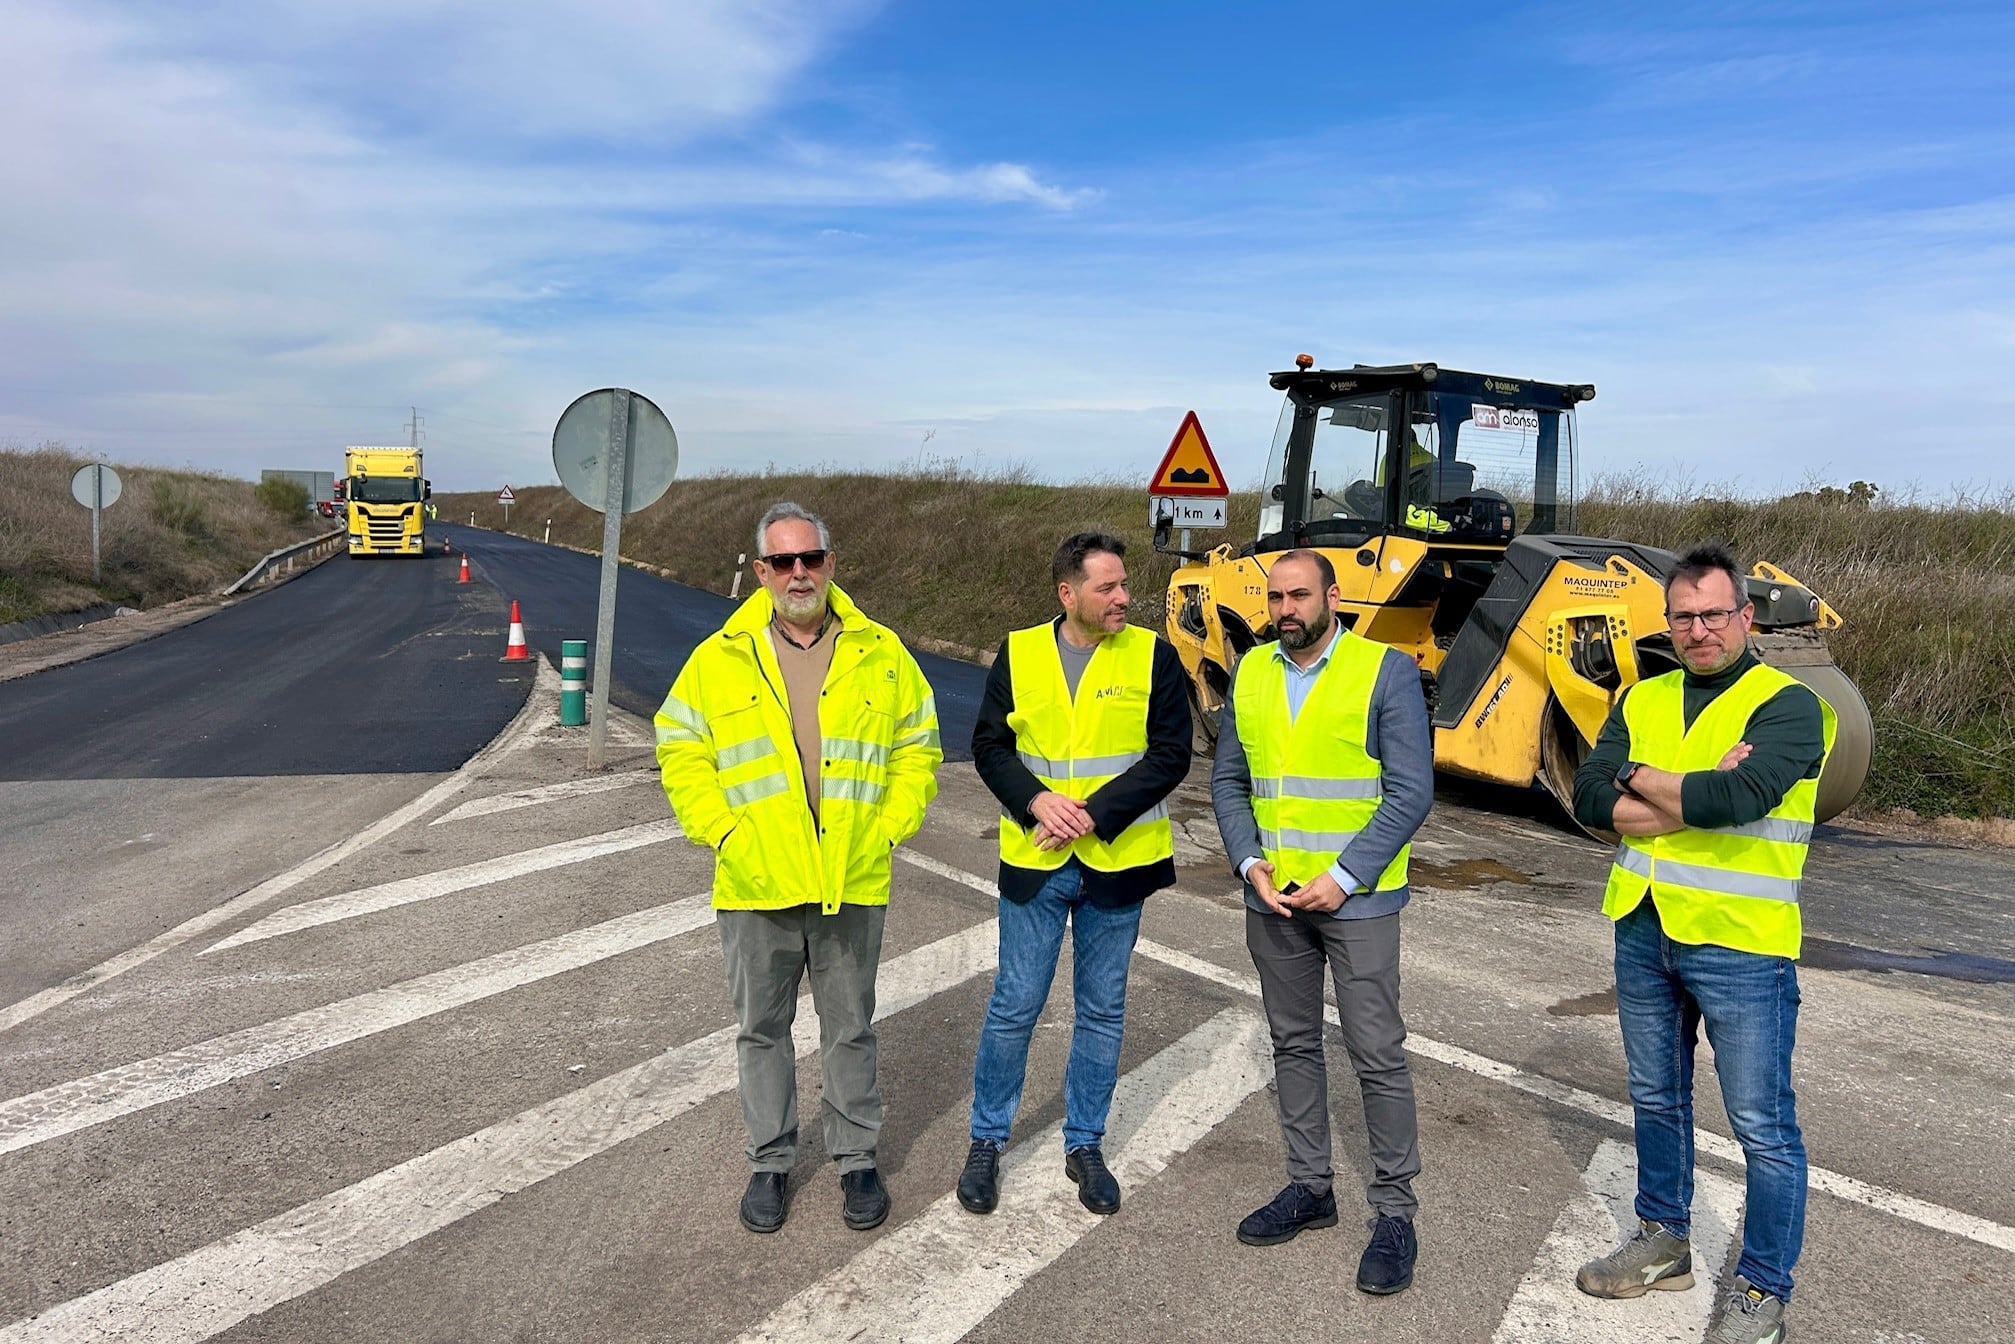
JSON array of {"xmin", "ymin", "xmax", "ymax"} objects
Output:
[{"xmin": 556, "ymin": 387, "xmax": 679, "ymax": 770}]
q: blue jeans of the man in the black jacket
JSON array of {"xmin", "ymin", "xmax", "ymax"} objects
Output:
[{"xmin": 973, "ymin": 858, "xmax": 1140, "ymax": 1151}]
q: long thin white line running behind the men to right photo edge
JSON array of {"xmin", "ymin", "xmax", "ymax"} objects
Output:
[{"xmin": 895, "ymin": 848, "xmax": 2015, "ymax": 1255}]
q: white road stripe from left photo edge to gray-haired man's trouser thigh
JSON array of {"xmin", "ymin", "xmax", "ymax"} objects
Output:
[{"xmin": 0, "ymin": 897, "xmax": 713, "ymax": 1153}]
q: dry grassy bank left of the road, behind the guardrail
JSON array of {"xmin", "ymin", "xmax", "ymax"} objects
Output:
[{"xmin": 0, "ymin": 443, "xmax": 328, "ymax": 623}]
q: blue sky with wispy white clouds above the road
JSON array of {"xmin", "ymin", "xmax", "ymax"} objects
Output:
[{"xmin": 0, "ymin": 0, "xmax": 2015, "ymax": 496}]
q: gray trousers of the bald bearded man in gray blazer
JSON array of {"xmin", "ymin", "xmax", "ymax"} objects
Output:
[{"xmin": 1245, "ymin": 911, "xmax": 1421, "ymax": 1219}]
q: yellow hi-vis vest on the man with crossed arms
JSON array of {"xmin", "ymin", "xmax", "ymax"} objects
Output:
[{"xmin": 1602, "ymin": 663, "xmax": 1840, "ymax": 959}]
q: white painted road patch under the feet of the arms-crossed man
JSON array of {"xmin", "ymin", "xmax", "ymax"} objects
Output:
[{"xmin": 1491, "ymin": 1138, "xmax": 1743, "ymax": 1344}]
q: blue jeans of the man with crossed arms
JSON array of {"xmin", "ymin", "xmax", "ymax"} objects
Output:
[{"xmin": 1616, "ymin": 895, "xmax": 1805, "ymax": 1302}]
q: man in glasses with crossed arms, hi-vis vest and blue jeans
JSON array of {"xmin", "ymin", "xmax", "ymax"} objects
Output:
[{"xmin": 1574, "ymin": 546, "xmax": 1836, "ymax": 1344}]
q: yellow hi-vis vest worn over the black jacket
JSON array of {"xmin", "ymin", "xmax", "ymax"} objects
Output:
[{"xmin": 999, "ymin": 623, "xmax": 1175, "ymax": 872}]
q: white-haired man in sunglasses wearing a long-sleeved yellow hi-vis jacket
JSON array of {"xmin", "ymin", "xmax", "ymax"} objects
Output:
[{"xmin": 657, "ymin": 502, "xmax": 943, "ymax": 1233}]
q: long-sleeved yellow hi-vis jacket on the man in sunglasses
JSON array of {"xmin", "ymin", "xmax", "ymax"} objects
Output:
[{"xmin": 657, "ymin": 584, "xmax": 945, "ymax": 915}]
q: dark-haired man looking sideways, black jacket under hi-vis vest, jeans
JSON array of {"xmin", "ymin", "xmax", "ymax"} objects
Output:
[{"xmin": 957, "ymin": 532, "xmax": 1189, "ymax": 1213}]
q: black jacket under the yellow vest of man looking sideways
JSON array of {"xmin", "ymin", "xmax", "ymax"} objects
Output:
[{"xmin": 973, "ymin": 617, "xmax": 1191, "ymax": 907}]
